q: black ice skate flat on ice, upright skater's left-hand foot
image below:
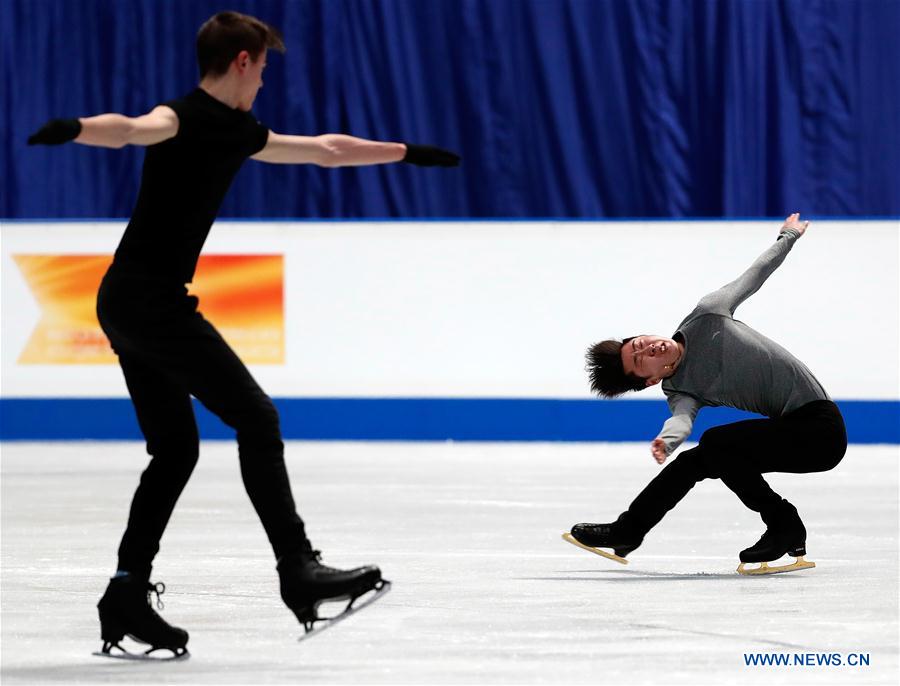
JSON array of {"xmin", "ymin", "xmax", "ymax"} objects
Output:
[{"xmin": 94, "ymin": 575, "xmax": 189, "ymax": 660}]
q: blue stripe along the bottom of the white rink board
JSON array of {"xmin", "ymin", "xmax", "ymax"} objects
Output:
[{"xmin": 0, "ymin": 398, "xmax": 900, "ymax": 443}]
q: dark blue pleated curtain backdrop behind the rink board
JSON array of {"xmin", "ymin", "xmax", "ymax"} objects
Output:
[{"xmin": 0, "ymin": 0, "xmax": 900, "ymax": 218}]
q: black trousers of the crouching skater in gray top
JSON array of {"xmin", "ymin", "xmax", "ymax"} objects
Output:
[{"xmin": 628, "ymin": 400, "xmax": 847, "ymax": 533}]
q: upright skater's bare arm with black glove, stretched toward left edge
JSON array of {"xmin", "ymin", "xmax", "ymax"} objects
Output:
[{"xmin": 28, "ymin": 105, "xmax": 178, "ymax": 148}]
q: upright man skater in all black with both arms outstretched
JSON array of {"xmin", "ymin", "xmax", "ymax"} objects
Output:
[{"xmin": 28, "ymin": 12, "xmax": 459, "ymax": 656}]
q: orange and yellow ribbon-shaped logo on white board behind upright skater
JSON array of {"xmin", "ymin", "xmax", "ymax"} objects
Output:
[{"xmin": 13, "ymin": 255, "xmax": 284, "ymax": 364}]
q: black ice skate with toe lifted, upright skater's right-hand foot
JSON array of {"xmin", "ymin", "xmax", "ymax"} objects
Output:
[{"xmin": 278, "ymin": 550, "xmax": 391, "ymax": 640}]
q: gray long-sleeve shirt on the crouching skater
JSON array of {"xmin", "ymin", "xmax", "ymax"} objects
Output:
[{"xmin": 658, "ymin": 229, "xmax": 830, "ymax": 455}]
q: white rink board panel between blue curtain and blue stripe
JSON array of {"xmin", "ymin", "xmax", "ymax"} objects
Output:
[{"xmin": 0, "ymin": 221, "xmax": 900, "ymax": 400}]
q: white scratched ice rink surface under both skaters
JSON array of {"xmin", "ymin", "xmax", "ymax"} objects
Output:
[{"xmin": 0, "ymin": 442, "xmax": 900, "ymax": 684}]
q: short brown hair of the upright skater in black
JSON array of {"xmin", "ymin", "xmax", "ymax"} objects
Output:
[{"xmin": 197, "ymin": 12, "xmax": 285, "ymax": 79}]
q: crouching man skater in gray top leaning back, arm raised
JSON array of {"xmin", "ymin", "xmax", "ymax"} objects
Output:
[{"xmin": 571, "ymin": 214, "xmax": 847, "ymax": 573}]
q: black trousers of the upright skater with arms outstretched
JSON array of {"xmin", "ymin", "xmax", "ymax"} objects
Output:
[{"xmin": 97, "ymin": 267, "xmax": 310, "ymax": 576}]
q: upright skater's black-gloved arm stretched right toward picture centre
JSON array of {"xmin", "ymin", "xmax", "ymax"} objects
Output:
[{"xmin": 253, "ymin": 131, "xmax": 459, "ymax": 167}]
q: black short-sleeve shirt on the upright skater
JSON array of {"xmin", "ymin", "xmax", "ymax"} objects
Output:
[{"xmin": 114, "ymin": 88, "xmax": 269, "ymax": 284}]
